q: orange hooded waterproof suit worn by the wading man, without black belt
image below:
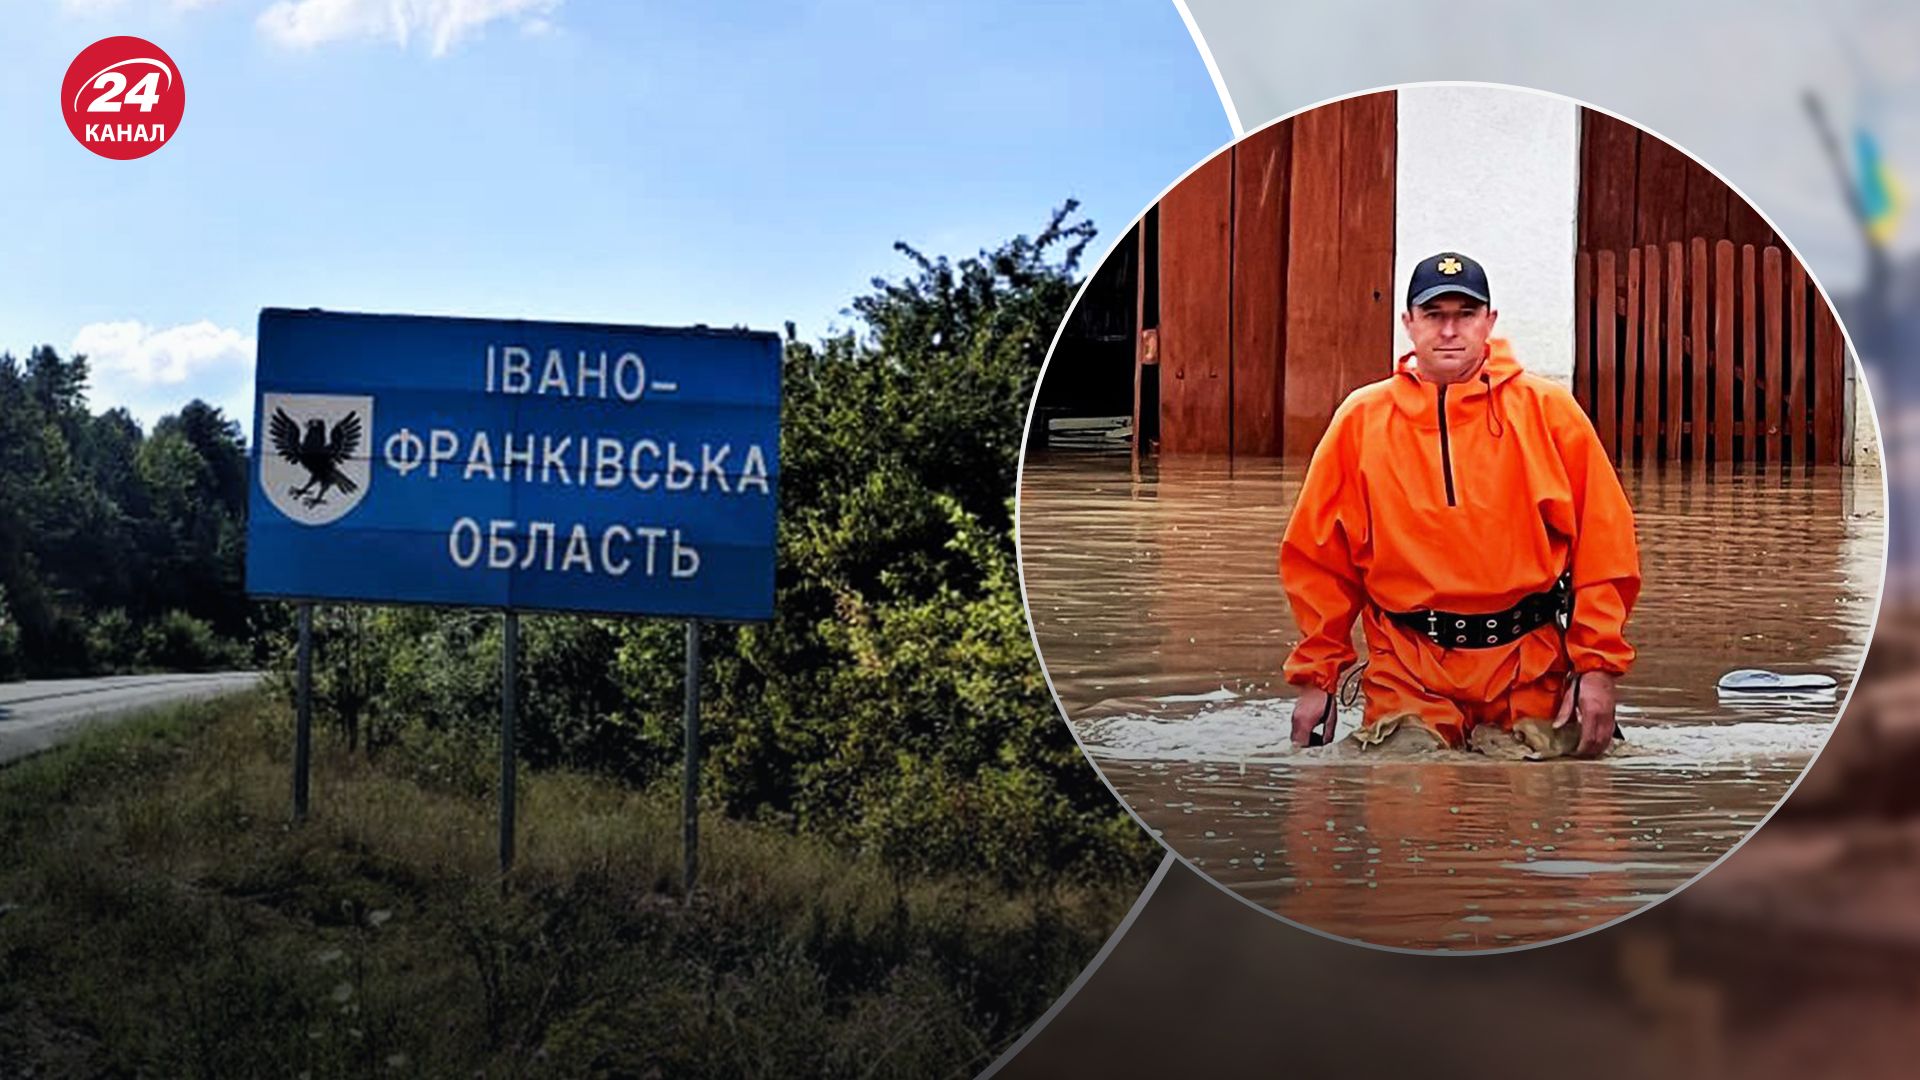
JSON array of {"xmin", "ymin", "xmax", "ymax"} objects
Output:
[{"xmin": 1281, "ymin": 338, "xmax": 1640, "ymax": 742}]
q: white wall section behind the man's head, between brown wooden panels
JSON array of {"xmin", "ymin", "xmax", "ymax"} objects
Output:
[{"xmin": 1394, "ymin": 86, "xmax": 1580, "ymax": 382}]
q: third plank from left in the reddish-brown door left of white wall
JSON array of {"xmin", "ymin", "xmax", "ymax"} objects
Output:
[{"xmin": 1281, "ymin": 98, "xmax": 1344, "ymax": 457}]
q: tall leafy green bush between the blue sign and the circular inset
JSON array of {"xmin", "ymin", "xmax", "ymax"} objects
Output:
[{"xmin": 679, "ymin": 204, "xmax": 1152, "ymax": 884}]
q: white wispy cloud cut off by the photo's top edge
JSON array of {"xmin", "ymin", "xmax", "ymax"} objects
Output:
[{"xmin": 255, "ymin": 0, "xmax": 561, "ymax": 56}]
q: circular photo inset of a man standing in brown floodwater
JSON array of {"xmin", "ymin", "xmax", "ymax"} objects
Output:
[{"xmin": 1018, "ymin": 85, "xmax": 1885, "ymax": 951}]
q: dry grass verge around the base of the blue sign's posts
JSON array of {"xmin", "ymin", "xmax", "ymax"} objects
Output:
[{"xmin": 0, "ymin": 694, "xmax": 1133, "ymax": 1078}]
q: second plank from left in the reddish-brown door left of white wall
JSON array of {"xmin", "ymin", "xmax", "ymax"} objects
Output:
[{"xmin": 1233, "ymin": 121, "xmax": 1292, "ymax": 455}]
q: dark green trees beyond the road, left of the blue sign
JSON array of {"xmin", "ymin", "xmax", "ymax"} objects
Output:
[{"xmin": 0, "ymin": 346, "xmax": 253, "ymax": 675}]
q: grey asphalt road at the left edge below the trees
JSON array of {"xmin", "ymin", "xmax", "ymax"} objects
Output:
[{"xmin": 0, "ymin": 671, "xmax": 261, "ymax": 765}]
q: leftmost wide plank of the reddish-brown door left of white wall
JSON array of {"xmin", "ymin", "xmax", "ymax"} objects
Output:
[{"xmin": 1160, "ymin": 154, "xmax": 1233, "ymax": 454}]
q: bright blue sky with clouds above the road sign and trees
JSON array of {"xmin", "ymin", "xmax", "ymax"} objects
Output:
[{"xmin": 0, "ymin": 0, "xmax": 1231, "ymax": 432}]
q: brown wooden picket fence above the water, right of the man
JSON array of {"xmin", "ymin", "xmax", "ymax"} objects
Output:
[{"xmin": 1574, "ymin": 236, "xmax": 1847, "ymax": 465}]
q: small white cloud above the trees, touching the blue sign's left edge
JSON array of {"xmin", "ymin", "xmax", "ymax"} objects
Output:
[{"xmin": 69, "ymin": 319, "xmax": 253, "ymax": 430}]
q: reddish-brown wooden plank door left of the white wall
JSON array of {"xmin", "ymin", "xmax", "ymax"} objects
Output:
[{"xmin": 1148, "ymin": 90, "xmax": 1396, "ymax": 455}]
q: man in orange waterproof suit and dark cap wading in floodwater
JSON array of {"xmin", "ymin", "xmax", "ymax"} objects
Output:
[{"xmin": 1281, "ymin": 252, "xmax": 1640, "ymax": 757}]
